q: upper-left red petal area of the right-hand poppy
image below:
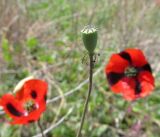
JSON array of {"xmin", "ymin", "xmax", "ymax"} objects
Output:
[{"xmin": 105, "ymin": 54, "xmax": 129, "ymax": 74}]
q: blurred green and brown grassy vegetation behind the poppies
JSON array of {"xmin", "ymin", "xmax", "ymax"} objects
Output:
[{"xmin": 0, "ymin": 0, "xmax": 160, "ymax": 137}]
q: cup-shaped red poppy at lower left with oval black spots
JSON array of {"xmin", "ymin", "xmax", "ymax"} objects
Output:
[{"xmin": 0, "ymin": 79, "xmax": 48, "ymax": 124}]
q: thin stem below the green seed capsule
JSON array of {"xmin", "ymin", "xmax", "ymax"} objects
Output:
[{"xmin": 76, "ymin": 54, "xmax": 94, "ymax": 137}]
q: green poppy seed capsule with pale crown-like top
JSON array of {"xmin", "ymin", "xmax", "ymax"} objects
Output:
[{"xmin": 81, "ymin": 25, "xmax": 97, "ymax": 53}]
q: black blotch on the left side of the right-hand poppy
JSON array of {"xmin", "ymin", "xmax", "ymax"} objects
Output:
[{"xmin": 107, "ymin": 72, "xmax": 124, "ymax": 86}]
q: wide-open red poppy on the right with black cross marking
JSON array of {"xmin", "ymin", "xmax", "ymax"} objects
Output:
[{"xmin": 105, "ymin": 49, "xmax": 154, "ymax": 101}]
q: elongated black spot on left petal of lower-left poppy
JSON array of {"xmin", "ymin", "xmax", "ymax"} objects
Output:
[{"xmin": 6, "ymin": 103, "xmax": 23, "ymax": 117}]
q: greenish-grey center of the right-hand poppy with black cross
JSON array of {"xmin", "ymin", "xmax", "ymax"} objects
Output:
[{"xmin": 124, "ymin": 66, "xmax": 138, "ymax": 77}]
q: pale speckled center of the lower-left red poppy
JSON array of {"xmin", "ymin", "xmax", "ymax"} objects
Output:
[{"xmin": 24, "ymin": 100, "xmax": 37, "ymax": 113}]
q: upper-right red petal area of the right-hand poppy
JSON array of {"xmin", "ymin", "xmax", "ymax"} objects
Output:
[{"xmin": 125, "ymin": 49, "xmax": 147, "ymax": 67}]
